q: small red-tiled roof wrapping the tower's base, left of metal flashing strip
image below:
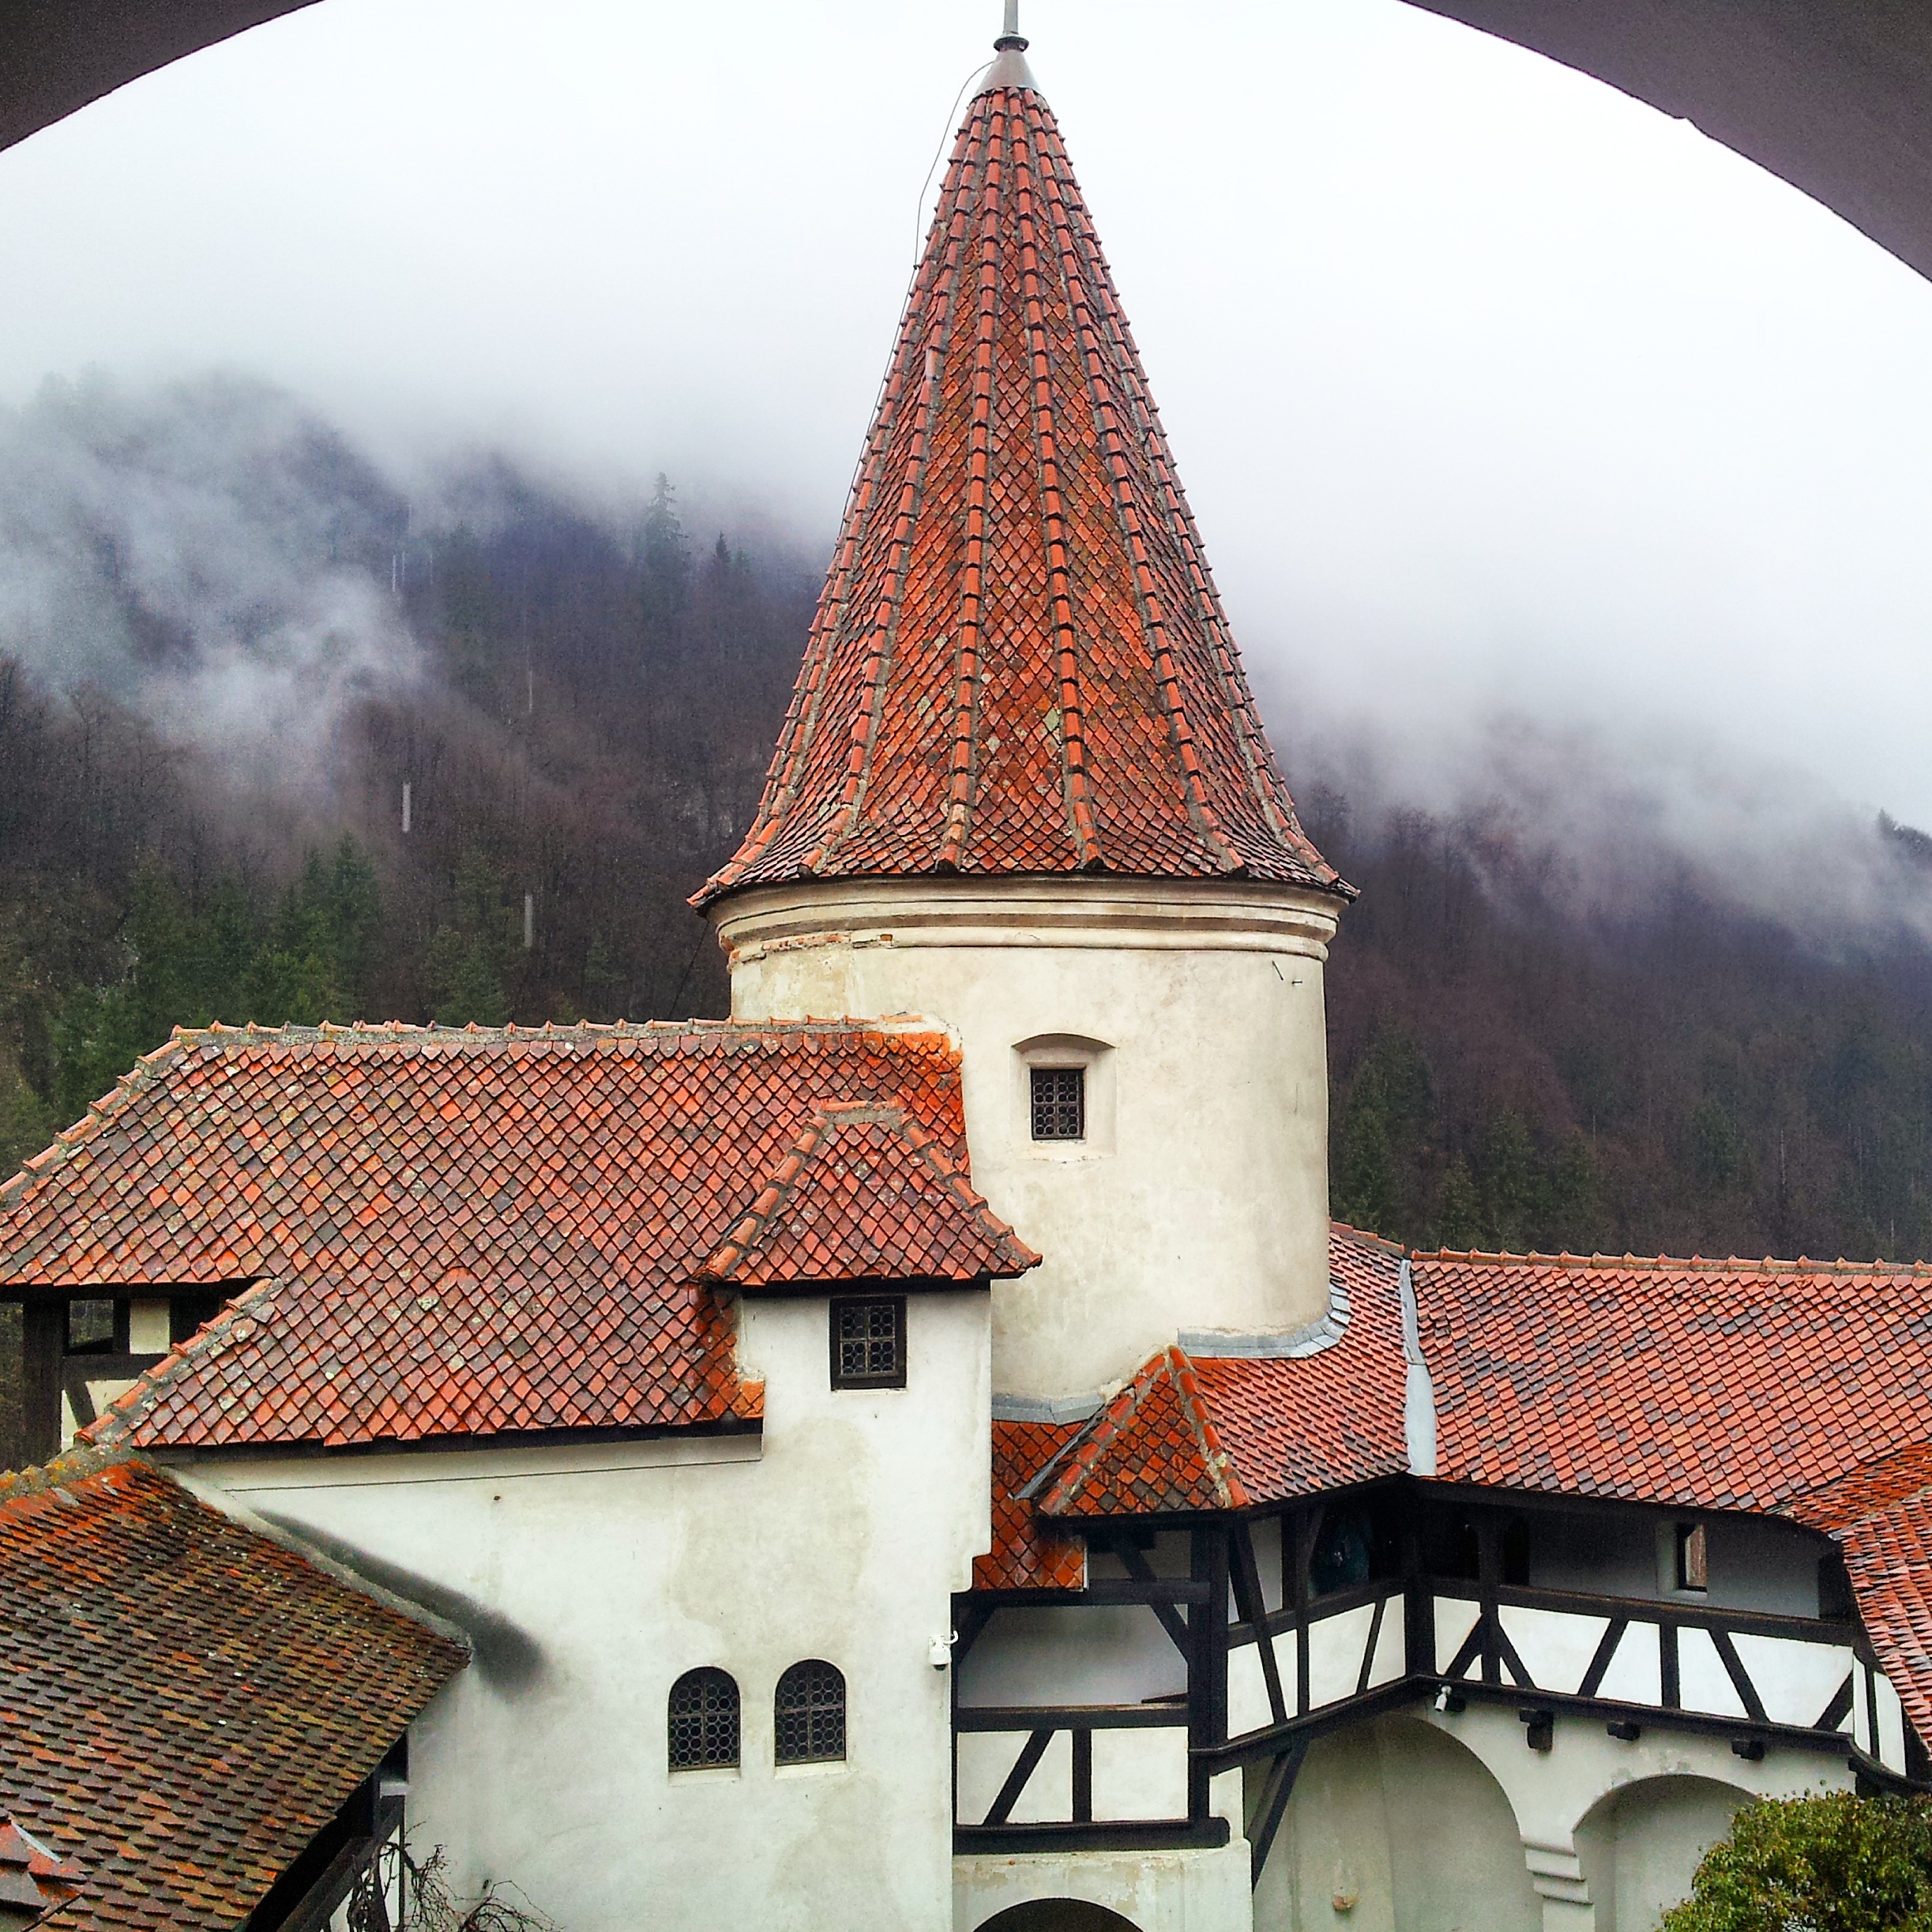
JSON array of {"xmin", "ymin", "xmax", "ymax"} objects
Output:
[{"xmin": 1036, "ymin": 1227, "xmax": 1408, "ymax": 1519}]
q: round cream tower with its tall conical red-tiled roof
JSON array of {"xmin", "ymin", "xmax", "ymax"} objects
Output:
[{"xmin": 697, "ymin": 18, "xmax": 1351, "ymax": 1403}]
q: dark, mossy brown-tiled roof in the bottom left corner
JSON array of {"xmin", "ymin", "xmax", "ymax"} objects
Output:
[{"xmin": 0, "ymin": 1451, "xmax": 465, "ymax": 1932}]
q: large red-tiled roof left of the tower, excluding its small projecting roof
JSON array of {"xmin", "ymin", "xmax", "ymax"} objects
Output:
[{"xmin": 0, "ymin": 1022, "xmax": 1012, "ymax": 1447}]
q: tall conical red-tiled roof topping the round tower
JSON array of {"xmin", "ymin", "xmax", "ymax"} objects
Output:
[{"xmin": 697, "ymin": 85, "xmax": 1351, "ymax": 904}]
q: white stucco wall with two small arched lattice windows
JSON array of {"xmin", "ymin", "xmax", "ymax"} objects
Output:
[{"xmin": 182, "ymin": 1291, "xmax": 991, "ymax": 1932}]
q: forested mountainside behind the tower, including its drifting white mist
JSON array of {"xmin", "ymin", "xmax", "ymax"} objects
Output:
[{"xmin": 0, "ymin": 377, "xmax": 1932, "ymax": 1437}]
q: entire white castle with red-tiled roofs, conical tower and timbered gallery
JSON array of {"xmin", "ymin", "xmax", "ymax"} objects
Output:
[{"xmin": 0, "ymin": 23, "xmax": 1932, "ymax": 1932}]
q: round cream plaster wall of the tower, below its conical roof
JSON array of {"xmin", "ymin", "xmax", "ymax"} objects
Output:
[{"xmin": 713, "ymin": 879, "xmax": 1339, "ymax": 1396}]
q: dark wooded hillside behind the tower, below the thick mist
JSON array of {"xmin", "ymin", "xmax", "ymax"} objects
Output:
[{"xmin": 0, "ymin": 380, "xmax": 1932, "ymax": 1447}]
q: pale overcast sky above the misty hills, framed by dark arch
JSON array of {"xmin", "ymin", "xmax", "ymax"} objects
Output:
[{"xmin": 0, "ymin": 0, "xmax": 1932, "ymax": 850}]
